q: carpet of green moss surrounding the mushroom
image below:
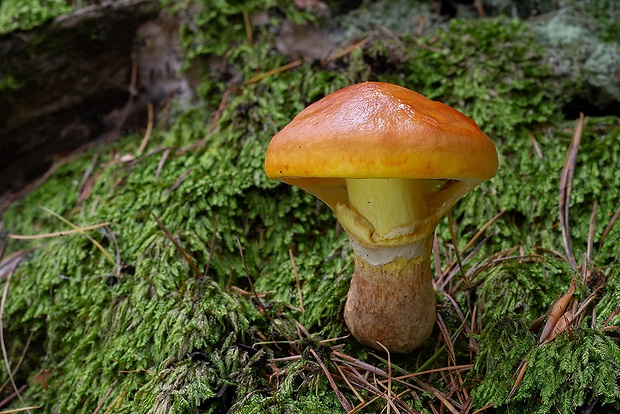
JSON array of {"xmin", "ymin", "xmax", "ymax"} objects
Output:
[{"xmin": 0, "ymin": 1, "xmax": 620, "ymax": 413}]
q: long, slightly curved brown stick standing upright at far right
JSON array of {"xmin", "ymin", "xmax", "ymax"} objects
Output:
[{"xmin": 558, "ymin": 113, "xmax": 584, "ymax": 271}]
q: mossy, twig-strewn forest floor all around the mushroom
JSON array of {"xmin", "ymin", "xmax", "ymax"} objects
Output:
[{"xmin": 0, "ymin": 0, "xmax": 620, "ymax": 413}]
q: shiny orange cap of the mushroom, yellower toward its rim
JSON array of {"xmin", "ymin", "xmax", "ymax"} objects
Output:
[{"xmin": 265, "ymin": 82, "xmax": 498, "ymax": 188}]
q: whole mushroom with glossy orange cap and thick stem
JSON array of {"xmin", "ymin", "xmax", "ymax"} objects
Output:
[{"xmin": 265, "ymin": 82, "xmax": 498, "ymax": 353}]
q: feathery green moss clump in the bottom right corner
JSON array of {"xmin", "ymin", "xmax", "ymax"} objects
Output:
[{"xmin": 472, "ymin": 320, "xmax": 620, "ymax": 414}]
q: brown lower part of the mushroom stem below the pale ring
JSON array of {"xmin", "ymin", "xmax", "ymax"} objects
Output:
[{"xmin": 344, "ymin": 237, "xmax": 436, "ymax": 353}]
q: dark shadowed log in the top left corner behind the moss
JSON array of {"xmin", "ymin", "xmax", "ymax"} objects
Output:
[{"xmin": 0, "ymin": 0, "xmax": 161, "ymax": 193}]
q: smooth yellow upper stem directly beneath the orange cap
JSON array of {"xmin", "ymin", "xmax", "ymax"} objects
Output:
[{"xmin": 347, "ymin": 178, "xmax": 427, "ymax": 238}]
